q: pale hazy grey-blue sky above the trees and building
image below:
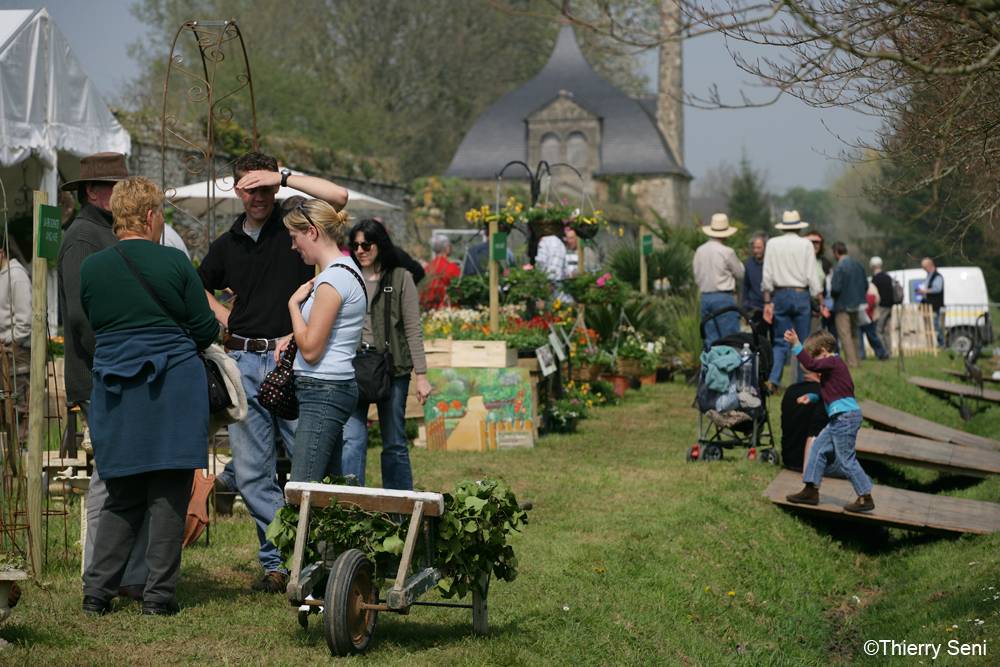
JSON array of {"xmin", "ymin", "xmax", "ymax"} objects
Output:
[{"xmin": 0, "ymin": 0, "xmax": 874, "ymax": 193}]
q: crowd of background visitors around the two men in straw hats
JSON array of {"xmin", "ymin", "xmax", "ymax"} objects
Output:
[{"xmin": 693, "ymin": 211, "xmax": 944, "ymax": 393}]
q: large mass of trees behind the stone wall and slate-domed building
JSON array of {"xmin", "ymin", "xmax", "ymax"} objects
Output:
[{"xmin": 132, "ymin": 0, "xmax": 635, "ymax": 180}]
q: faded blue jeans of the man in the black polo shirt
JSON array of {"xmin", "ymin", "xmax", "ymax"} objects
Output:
[{"xmin": 229, "ymin": 351, "xmax": 296, "ymax": 572}]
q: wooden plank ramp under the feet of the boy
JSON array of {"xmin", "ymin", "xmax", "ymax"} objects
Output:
[{"xmin": 764, "ymin": 470, "xmax": 1000, "ymax": 535}]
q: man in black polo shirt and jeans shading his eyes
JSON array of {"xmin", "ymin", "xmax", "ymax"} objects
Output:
[{"xmin": 198, "ymin": 153, "xmax": 347, "ymax": 593}]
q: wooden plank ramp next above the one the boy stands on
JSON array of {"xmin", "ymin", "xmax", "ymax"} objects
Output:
[{"xmin": 856, "ymin": 428, "xmax": 1000, "ymax": 477}]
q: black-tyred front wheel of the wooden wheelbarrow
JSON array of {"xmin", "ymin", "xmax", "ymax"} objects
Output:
[{"xmin": 323, "ymin": 549, "xmax": 378, "ymax": 656}]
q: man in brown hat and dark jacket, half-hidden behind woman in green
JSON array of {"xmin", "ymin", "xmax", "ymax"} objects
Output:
[{"xmin": 59, "ymin": 153, "xmax": 149, "ymax": 598}]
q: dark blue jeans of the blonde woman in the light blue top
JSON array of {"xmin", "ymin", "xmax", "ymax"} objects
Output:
[{"xmin": 291, "ymin": 375, "xmax": 358, "ymax": 482}]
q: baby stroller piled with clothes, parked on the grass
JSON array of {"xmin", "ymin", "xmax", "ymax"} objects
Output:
[{"xmin": 687, "ymin": 306, "xmax": 778, "ymax": 465}]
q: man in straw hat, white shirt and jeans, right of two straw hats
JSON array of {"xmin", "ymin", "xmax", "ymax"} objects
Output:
[{"xmin": 761, "ymin": 211, "xmax": 823, "ymax": 391}]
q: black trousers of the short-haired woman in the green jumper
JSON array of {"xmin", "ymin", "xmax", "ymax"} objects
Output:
[{"xmin": 83, "ymin": 470, "xmax": 194, "ymax": 603}]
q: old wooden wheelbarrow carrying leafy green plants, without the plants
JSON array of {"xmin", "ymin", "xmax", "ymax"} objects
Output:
[{"xmin": 285, "ymin": 482, "xmax": 489, "ymax": 655}]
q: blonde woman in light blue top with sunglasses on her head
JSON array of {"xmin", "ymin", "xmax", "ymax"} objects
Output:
[{"xmin": 275, "ymin": 199, "xmax": 365, "ymax": 482}]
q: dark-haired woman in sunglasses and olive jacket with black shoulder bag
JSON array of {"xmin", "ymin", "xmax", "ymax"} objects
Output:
[{"xmin": 343, "ymin": 220, "xmax": 431, "ymax": 490}]
